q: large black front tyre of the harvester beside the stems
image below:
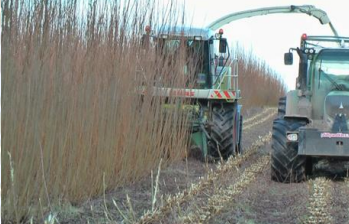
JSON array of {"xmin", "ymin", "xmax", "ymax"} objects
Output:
[{"xmin": 208, "ymin": 104, "xmax": 236, "ymax": 159}]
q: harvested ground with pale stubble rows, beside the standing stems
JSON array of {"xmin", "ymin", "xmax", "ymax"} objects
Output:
[{"xmin": 59, "ymin": 109, "xmax": 349, "ymax": 223}]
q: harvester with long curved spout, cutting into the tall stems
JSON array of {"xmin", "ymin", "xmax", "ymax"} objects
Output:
[{"xmin": 143, "ymin": 5, "xmax": 338, "ymax": 159}]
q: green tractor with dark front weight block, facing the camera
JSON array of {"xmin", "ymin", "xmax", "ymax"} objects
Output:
[{"xmin": 271, "ymin": 34, "xmax": 349, "ymax": 182}]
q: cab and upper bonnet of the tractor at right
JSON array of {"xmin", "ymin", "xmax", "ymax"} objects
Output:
[{"xmin": 284, "ymin": 34, "xmax": 349, "ymax": 126}]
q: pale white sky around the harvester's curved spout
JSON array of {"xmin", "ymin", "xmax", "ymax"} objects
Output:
[{"xmin": 181, "ymin": 0, "xmax": 349, "ymax": 90}]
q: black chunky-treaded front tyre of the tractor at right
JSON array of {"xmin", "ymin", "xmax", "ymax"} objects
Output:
[{"xmin": 271, "ymin": 118, "xmax": 306, "ymax": 183}]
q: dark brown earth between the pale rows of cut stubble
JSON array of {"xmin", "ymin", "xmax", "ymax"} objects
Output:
[{"xmin": 57, "ymin": 109, "xmax": 349, "ymax": 223}]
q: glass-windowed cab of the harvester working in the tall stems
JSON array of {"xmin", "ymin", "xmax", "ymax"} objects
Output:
[{"xmin": 142, "ymin": 26, "xmax": 237, "ymax": 91}]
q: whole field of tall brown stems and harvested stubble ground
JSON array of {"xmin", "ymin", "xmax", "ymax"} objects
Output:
[{"xmin": 1, "ymin": 0, "xmax": 349, "ymax": 223}]
